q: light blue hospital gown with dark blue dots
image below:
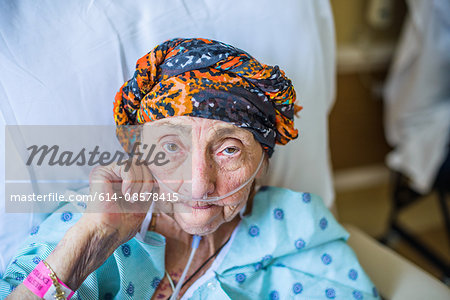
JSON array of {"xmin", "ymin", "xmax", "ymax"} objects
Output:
[{"xmin": 0, "ymin": 187, "xmax": 379, "ymax": 300}]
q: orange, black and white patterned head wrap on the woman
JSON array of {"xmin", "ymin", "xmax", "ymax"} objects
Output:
[{"xmin": 114, "ymin": 38, "xmax": 301, "ymax": 156}]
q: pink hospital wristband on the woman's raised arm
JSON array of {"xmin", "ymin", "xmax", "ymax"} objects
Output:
[{"xmin": 23, "ymin": 261, "xmax": 74, "ymax": 300}]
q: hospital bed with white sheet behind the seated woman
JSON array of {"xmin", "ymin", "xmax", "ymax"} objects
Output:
[{"xmin": 0, "ymin": 0, "xmax": 448, "ymax": 299}]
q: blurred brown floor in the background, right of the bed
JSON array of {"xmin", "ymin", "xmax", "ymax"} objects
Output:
[{"xmin": 335, "ymin": 167, "xmax": 450, "ymax": 284}]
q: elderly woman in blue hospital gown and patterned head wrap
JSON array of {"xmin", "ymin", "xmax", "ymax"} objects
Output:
[{"xmin": 0, "ymin": 39, "xmax": 378, "ymax": 299}]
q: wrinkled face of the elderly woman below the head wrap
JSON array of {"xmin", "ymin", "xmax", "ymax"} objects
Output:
[{"xmin": 142, "ymin": 117, "xmax": 264, "ymax": 235}]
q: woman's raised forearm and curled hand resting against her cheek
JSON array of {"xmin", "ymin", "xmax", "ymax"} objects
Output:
[{"xmin": 8, "ymin": 164, "xmax": 153, "ymax": 299}]
